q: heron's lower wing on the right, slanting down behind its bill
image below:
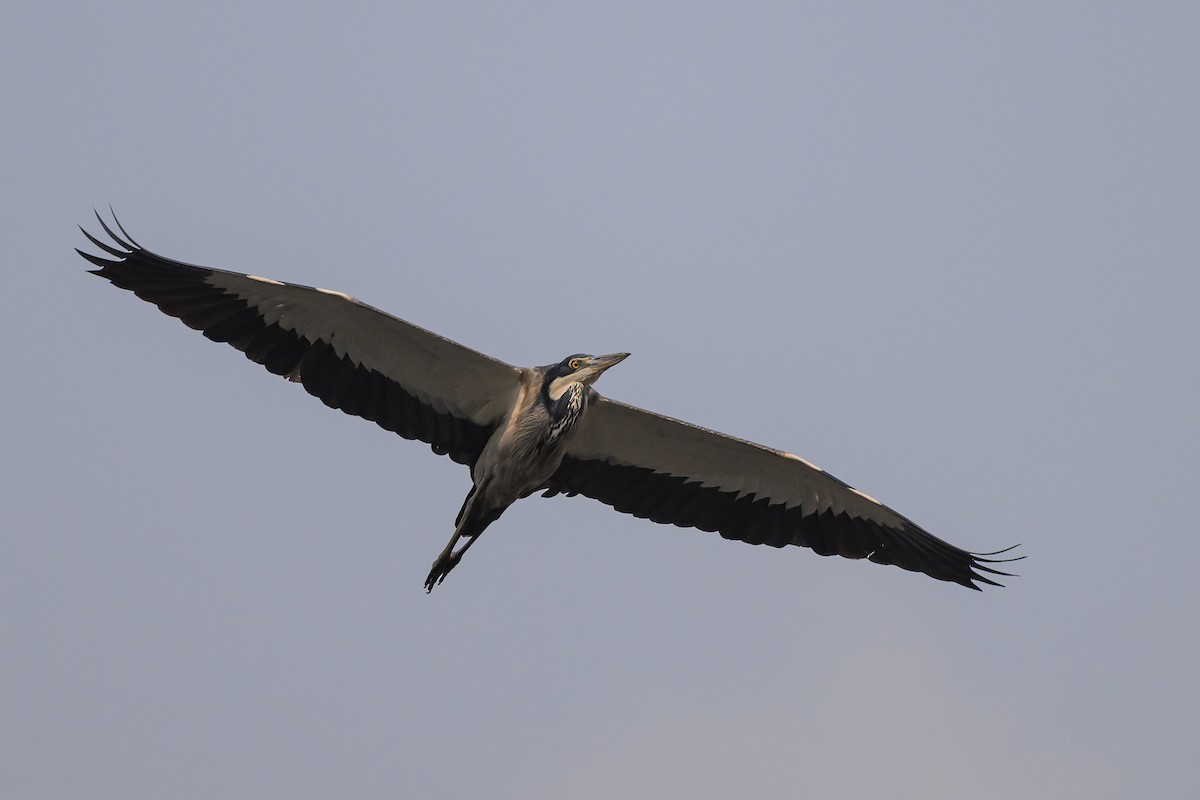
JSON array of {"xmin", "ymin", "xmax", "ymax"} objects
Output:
[{"xmin": 548, "ymin": 396, "xmax": 1015, "ymax": 589}]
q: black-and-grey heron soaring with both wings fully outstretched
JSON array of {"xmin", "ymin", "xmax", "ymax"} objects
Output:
[{"xmin": 77, "ymin": 213, "xmax": 1015, "ymax": 591}]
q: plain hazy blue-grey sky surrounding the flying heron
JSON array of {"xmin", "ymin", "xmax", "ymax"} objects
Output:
[{"xmin": 0, "ymin": 2, "xmax": 1200, "ymax": 800}]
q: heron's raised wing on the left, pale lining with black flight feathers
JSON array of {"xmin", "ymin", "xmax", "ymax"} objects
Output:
[{"xmin": 77, "ymin": 213, "xmax": 521, "ymax": 465}]
